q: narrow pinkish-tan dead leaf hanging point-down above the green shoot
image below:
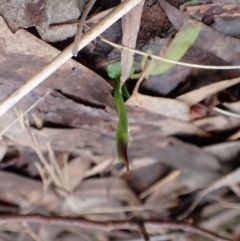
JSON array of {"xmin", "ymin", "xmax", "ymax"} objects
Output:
[{"xmin": 121, "ymin": 0, "xmax": 144, "ymax": 84}]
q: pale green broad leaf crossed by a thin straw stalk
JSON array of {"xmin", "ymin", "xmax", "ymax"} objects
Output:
[{"xmin": 141, "ymin": 20, "xmax": 202, "ymax": 78}]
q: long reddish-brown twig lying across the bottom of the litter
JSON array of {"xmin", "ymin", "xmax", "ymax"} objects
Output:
[{"xmin": 0, "ymin": 214, "xmax": 230, "ymax": 241}]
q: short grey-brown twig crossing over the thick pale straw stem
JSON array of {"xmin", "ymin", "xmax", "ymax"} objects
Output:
[{"xmin": 73, "ymin": 0, "xmax": 96, "ymax": 56}]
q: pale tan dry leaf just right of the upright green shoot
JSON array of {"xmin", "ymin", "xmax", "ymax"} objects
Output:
[{"xmin": 126, "ymin": 94, "xmax": 191, "ymax": 121}]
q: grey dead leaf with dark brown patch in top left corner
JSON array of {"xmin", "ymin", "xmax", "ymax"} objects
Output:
[{"xmin": 0, "ymin": 0, "xmax": 81, "ymax": 42}]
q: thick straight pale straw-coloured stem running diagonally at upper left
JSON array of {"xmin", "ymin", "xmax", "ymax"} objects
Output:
[{"xmin": 0, "ymin": 0, "xmax": 141, "ymax": 115}]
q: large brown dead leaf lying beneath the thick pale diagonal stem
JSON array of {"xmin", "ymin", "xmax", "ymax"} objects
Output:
[{"xmin": 0, "ymin": 18, "xmax": 112, "ymax": 109}]
